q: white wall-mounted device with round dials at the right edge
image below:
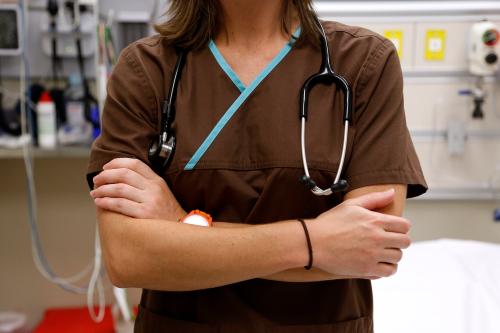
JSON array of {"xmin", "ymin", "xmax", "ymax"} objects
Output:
[{"xmin": 468, "ymin": 20, "xmax": 500, "ymax": 119}]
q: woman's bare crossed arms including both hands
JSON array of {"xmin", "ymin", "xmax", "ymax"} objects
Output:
[{"xmin": 91, "ymin": 159, "xmax": 409, "ymax": 290}]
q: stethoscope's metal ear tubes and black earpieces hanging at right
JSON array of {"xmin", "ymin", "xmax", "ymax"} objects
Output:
[{"xmin": 299, "ymin": 20, "xmax": 352, "ymax": 196}]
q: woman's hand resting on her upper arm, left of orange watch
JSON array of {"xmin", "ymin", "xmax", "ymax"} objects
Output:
[{"xmin": 90, "ymin": 158, "xmax": 186, "ymax": 221}]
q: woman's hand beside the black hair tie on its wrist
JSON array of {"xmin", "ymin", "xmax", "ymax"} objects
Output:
[{"xmin": 306, "ymin": 190, "xmax": 411, "ymax": 279}]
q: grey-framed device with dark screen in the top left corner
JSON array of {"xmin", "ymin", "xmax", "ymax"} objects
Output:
[{"xmin": 0, "ymin": 3, "xmax": 23, "ymax": 56}]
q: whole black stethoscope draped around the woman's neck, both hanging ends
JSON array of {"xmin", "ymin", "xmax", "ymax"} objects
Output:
[{"xmin": 148, "ymin": 16, "xmax": 352, "ymax": 196}]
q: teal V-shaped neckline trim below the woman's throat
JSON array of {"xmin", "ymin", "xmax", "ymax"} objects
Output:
[{"xmin": 208, "ymin": 27, "xmax": 301, "ymax": 93}]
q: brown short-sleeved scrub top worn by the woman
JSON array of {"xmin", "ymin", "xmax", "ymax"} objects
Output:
[{"xmin": 88, "ymin": 22, "xmax": 426, "ymax": 333}]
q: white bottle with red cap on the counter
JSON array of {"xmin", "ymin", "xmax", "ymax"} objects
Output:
[{"xmin": 36, "ymin": 91, "xmax": 57, "ymax": 149}]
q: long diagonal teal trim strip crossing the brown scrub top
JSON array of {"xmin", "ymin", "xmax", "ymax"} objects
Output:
[{"xmin": 184, "ymin": 27, "xmax": 301, "ymax": 170}]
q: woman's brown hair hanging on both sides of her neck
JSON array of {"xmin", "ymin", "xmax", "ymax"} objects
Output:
[{"xmin": 155, "ymin": 0, "xmax": 318, "ymax": 50}]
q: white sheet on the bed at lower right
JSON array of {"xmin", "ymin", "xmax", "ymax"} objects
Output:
[{"xmin": 373, "ymin": 240, "xmax": 500, "ymax": 333}]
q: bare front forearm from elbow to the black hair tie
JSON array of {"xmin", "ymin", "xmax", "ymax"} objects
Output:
[{"xmin": 98, "ymin": 210, "xmax": 307, "ymax": 291}]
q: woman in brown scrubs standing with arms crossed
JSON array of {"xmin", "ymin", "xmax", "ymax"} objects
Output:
[{"xmin": 88, "ymin": 0, "xmax": 426, "ymax": 333}]
